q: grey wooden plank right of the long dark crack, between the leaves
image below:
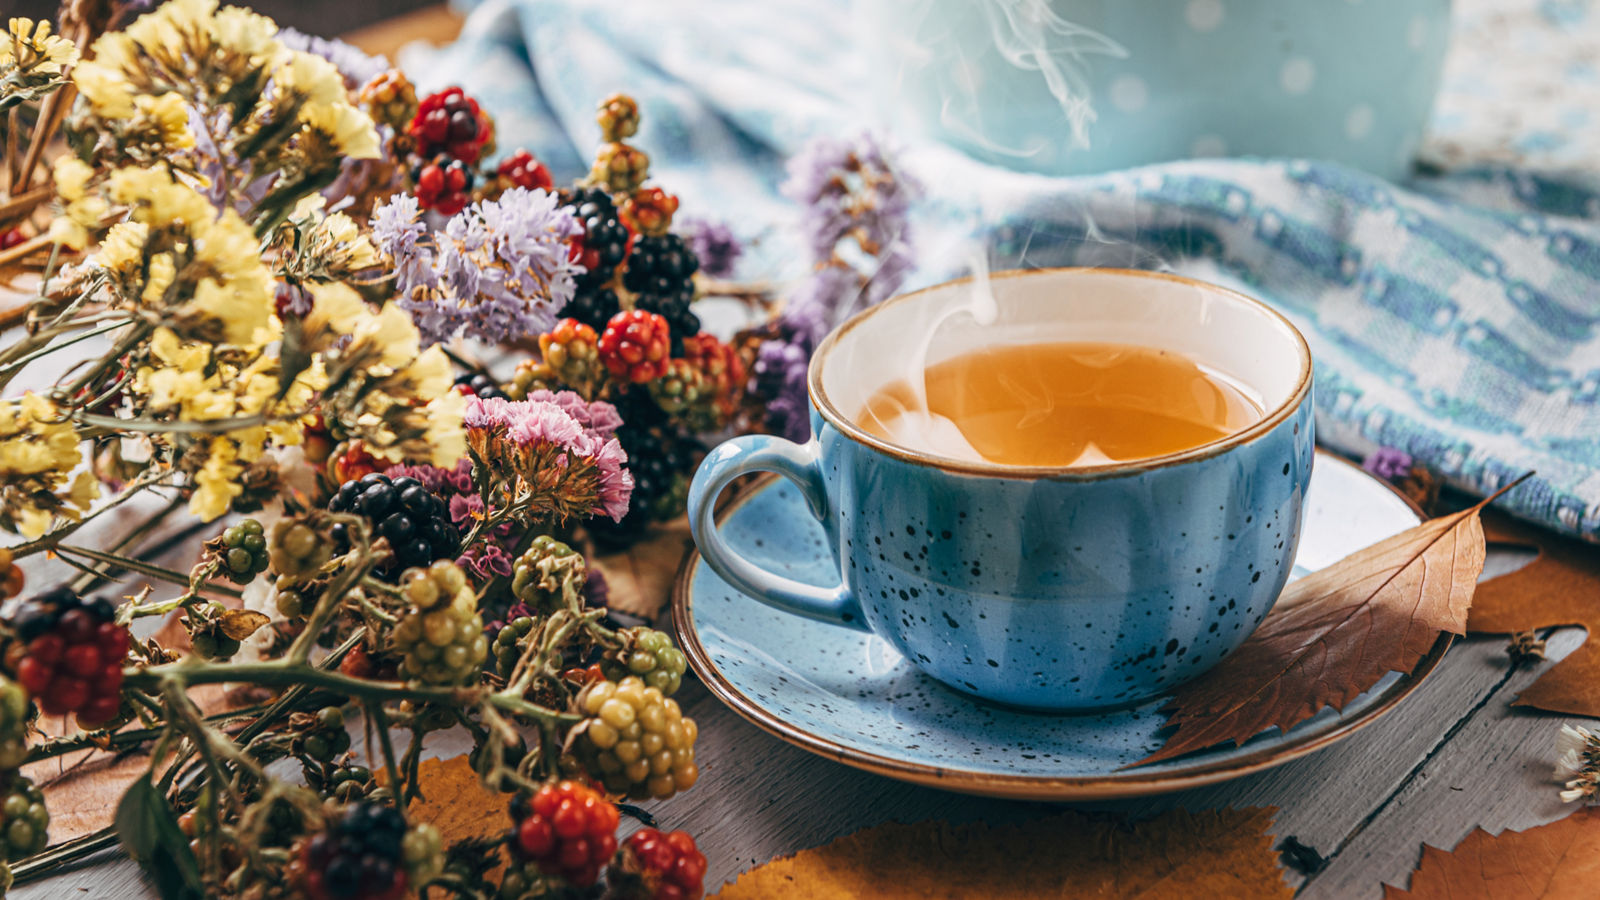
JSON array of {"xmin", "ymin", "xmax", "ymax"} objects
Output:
[{"xmin": 1301, "ymin": 628, "xmax": 1594, "ymax": 900}]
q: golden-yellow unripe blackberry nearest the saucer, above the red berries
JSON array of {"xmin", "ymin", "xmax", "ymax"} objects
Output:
[{"xmin": 576, "ymin": 676, "xmax": 699, "ymax": 799}]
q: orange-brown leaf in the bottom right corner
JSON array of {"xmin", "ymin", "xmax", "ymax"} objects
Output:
[{"xmin": 1384, "ymin": 807, "xmax": 1600, "ymax": 900}]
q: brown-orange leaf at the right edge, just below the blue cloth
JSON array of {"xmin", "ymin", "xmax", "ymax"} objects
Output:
[{"xmin": 1467, "ymin": 516, "xmax": 1600, "ymax": 717}]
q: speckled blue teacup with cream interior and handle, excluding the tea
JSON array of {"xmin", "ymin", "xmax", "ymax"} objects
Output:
[{"xmin": 690, "ymin": 269, "xmax": 1312, "ymax": 711}]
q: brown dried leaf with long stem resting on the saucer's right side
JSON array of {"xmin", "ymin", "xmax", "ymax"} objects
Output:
[{"xmin": 1134, "ymin": 501, "xmax": 1488, "ymax": 765}]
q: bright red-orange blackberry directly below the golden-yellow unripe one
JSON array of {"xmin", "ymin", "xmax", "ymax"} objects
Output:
[{"xmin": 509, "ymin": 781, "xmax": 621, "ymax": 887}]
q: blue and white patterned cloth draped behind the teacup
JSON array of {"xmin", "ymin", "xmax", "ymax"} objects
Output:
[{"xmin": 403, "ymin": 0, "xmax": 1600, "ymax": 541}]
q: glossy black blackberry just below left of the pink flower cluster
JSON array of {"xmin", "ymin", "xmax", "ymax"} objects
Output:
[{"xmin": 328, "ymin": 472, "xmax": 461, "ymax": 577}]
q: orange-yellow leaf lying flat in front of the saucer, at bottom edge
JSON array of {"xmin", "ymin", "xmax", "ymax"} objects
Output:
[{"xmin": 717, "ymin": 809, "xmax": 1294, "ymax": 900}]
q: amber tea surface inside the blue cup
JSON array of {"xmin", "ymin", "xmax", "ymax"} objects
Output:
[{"xmin": 856, "ymin": 343, "xmax": 1262, "ymax": 468}]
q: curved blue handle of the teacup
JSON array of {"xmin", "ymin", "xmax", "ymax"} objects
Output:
[{"xmin": 690, "ymin": 434, "xmax": 867, "ymax": 631}]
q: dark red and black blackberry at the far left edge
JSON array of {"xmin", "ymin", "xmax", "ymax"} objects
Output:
[{"xmin": 11, "ymin": 588, "xmax": 128, "ymax": 729}]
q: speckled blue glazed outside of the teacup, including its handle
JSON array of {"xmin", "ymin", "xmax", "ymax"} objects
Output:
[{"xmin": 690, "ymin": 391, "xmax": 1314, "ymax": 709}]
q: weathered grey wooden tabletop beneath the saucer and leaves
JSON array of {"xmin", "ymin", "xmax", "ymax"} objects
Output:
[{"xmin": 11, "ymin": 3, "xmax": 1584, "ymax": 900}]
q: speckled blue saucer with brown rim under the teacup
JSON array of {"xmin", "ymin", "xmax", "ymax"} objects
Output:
[{"xmin": 672, "ymin": 453, "xmax": 1450, "ymax": 801}]
